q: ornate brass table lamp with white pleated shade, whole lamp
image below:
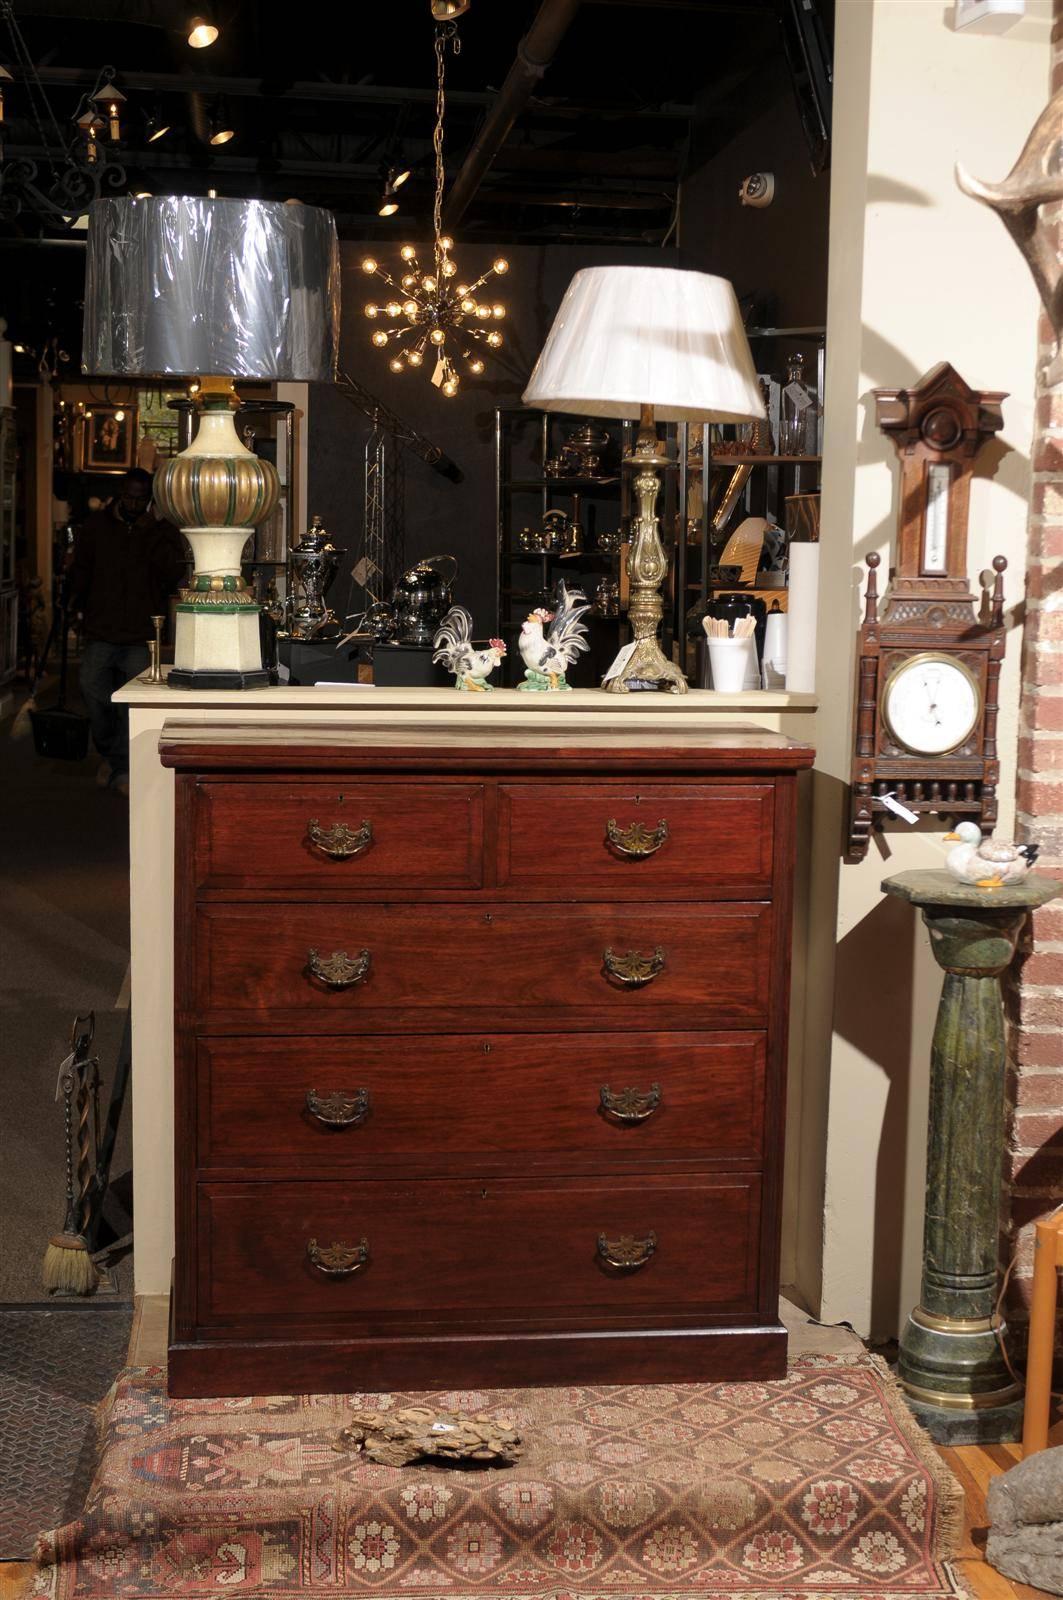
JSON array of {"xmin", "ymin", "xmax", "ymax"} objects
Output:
[{"xmin": 522, "ymin": 267, "xmax": 765, "ymax": 694}]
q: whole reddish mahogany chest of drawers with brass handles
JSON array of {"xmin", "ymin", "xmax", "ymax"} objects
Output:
[{"xmin": 162, "ymin": 726, "xmax": 812, "ymax": 1395}]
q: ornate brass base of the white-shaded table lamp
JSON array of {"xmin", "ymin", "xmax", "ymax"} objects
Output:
[{"xmin": 605, "ymin": 405, "xmax": 687, "ymax": 694}]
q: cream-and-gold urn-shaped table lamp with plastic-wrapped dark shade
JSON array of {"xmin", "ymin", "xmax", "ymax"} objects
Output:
[{"xmin": 82, "ymin": 197, "xmax": 339, "ymax": 688}]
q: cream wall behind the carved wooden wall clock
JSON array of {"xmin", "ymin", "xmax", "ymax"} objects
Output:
[{"xmin": 810, "ymin": 0, "xmax": 1050, "ymax": 1334}]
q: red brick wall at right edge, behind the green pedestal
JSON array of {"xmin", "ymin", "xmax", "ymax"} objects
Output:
[{"xmin": 1009, "ymin": 0, "xmax": 1063, "ymax": 1350}]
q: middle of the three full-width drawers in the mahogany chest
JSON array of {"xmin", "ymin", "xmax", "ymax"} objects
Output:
[{"xmin": 197, "ymin": 1034, "xmax": 764, "ymax": 1176}]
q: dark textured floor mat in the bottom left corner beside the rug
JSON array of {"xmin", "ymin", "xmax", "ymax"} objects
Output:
[{"xmin": 0, "ymin": 1306, "xmax": 133, "ymax": 1560}]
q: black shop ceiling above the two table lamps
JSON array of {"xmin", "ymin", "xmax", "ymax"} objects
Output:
[{"xmin": 0, "ymin": 0, "xmax": 829, "ymax": 243}]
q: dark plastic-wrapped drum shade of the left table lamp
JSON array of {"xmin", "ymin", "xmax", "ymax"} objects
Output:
[{"xmin": 82, "ymin": 197, "xmax": 339, "ymax": 382}]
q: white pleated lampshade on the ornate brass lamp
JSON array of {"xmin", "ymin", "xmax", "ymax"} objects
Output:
[{"xmin": 523, "ymin": 267, "xmax": 765, "ymax": 422}]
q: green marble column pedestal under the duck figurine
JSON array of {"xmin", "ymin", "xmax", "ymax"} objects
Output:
[{"xmin": 882, "ymin": 869, "xmax": 1063, "ymax": 1445}]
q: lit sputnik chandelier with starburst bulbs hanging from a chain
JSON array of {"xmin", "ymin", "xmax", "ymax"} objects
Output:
[{"xmin": 362, "ymin": 22, "xmax": 509, "ymax": 400}]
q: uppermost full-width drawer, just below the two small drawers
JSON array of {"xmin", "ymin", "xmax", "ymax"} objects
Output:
[{"xmin": 197, "ymin": 901, "xmax": 772, "ymax": 1032}]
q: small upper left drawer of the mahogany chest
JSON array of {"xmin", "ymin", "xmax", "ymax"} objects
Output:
[{"xmin": 195, "ymin": 779, "xmax": 483, "ymax": 893}]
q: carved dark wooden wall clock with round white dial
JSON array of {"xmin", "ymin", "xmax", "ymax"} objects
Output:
[{"xmin": 848, "ymin": 362, "xmax": 1007, "ymax": 859}]
